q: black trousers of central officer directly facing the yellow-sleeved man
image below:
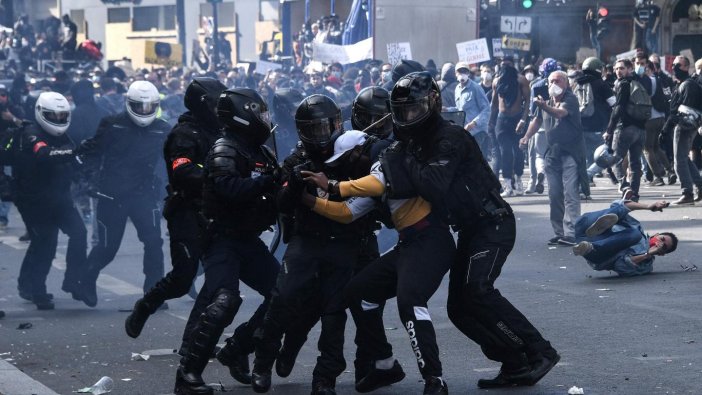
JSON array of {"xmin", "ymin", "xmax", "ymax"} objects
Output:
[{"xmin": 256, "ymin": 235, "xmax": 361, "ymax": 382}]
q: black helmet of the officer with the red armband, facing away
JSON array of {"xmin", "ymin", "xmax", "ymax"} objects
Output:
[{"xmin": 183, "ymin": 77, "xmax": 227, "ymax": 129}]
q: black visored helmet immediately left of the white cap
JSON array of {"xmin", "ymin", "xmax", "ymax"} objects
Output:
[{"xmin": 295, "ymin": 95, "xmax": 344, "ymax": 160}]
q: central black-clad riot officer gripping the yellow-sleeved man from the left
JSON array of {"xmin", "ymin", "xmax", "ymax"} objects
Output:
[{"xmin": 252, "ymin": 95, "xmax": 374, "ymax": 395}]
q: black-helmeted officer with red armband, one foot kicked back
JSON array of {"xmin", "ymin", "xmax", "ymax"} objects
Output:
[{"xmin": 125, "ymin": 77, "xmax": 227, "ymax": 340}]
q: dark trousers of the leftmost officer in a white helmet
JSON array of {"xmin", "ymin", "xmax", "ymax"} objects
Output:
[{"xmin": 17, "ymin": 197, "xmax": 88, "ymax": 297}]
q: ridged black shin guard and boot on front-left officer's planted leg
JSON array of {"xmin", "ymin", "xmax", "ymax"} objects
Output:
[{"xmin": 174, "ymin": 289, "xmax": 241, "ymax": 395}]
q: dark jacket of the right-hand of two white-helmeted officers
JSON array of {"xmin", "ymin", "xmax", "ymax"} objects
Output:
[{"xmin": 80, "ymin": 112, "xmax": 170, "ymax": 199}]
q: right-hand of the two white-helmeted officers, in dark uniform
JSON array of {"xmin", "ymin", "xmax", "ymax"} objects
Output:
[{"xmin": 80, "ymin": 81, "xmax": 170, "ymax": 307}]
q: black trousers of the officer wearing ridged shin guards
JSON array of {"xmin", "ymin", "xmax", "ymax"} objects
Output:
[{"xmin": 197, "ymin": 233, "xmax": 280, "ymax": 355}]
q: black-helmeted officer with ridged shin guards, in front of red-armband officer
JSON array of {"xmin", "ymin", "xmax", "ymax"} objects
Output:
[{"xmin": 175, "ymin": 88, "xmax": 279, "ymax": 395}]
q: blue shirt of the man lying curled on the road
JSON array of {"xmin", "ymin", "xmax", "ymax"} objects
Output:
[{"xmin": 587, "ymin": 200, "xmax": 655, "ymax": 277}]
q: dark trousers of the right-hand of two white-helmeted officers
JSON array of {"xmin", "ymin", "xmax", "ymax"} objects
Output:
[{"xmin": 88, "ymin": 194, "xmax": 164, "ymax": 292}]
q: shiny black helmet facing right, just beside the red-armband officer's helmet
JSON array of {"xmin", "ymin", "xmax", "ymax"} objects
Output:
[{"xmin": 217, "ymin": 88, "xmax": 271, "ymax": 145}]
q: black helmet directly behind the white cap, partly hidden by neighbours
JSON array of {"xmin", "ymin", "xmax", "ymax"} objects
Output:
[{"xmin": 351, "ymin": 86, "xmax": 392, "ymax": 139}]
